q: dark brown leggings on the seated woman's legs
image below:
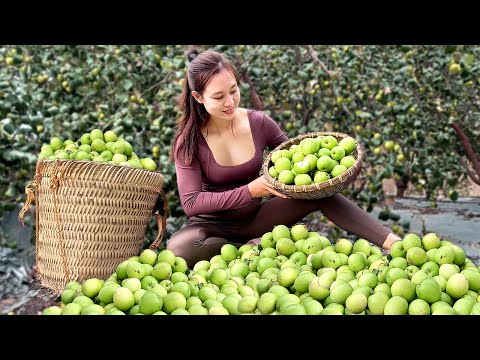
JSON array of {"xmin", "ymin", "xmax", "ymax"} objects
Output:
[{"xmin": 167, "ymin": 194, "xmax": 391, "ymax": 268}]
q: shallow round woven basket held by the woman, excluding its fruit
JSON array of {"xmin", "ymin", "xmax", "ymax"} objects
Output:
[{"xmin": 262, "ymin": 132, "xmax": 364, "ymax": 200}]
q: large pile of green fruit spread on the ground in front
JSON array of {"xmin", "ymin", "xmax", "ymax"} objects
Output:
[{"xmin": 43, "ymin": 224, "xmax": 480, "ymax": 315}]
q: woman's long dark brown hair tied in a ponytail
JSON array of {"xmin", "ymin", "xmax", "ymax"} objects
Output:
[{"xmin": 170, "ymin": 49, "xmax": 239, "ymax": 165}]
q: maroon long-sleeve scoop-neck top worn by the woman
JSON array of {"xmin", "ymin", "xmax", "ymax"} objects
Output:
[{"xmin": 175, "ymin": 110, "xmax": 288, "ymax": 219}]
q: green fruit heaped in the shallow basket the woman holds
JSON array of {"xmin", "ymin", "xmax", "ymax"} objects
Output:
[{"xmin": 268, "ymin": 135, "xmax": 357, "ymax": 185}]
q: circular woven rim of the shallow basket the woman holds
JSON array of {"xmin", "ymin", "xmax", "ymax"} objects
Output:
[{"xmin": 262, "ymin": 131, "xmax": 364, "ymax": 194}]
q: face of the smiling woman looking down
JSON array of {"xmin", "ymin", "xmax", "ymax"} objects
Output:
[{"xmin": 192, "ymin": 70, "xmax": 240, "ymax": 120}]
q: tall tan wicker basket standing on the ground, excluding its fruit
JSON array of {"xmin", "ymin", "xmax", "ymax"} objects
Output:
[{"xmin": 19, "ymin": 160, "xmax": 168, "ymax": 292}]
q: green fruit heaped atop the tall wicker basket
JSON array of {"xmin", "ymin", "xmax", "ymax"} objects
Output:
[{"xmin": 38, "ymin": 129, "xmax": 157, "ymax": 171}]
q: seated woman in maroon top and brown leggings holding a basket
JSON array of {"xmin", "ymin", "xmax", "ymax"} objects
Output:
[{"xmin": 167, "ymin": 50, "xmax": 400, "ymax": 267}]
